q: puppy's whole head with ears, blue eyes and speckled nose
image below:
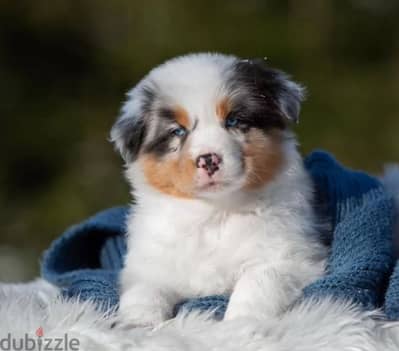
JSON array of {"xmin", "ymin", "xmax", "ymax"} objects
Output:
[{"xmin": 111, "ymin": 54, "xmax": 302, "ymax": 198}]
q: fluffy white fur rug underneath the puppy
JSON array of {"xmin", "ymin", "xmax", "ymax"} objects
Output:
[{"xmin": 0, "ymin": 167, "xmax": 399, "ymax": 351}]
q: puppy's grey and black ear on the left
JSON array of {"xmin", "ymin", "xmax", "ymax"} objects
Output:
[{"xmin": 110, "ymin": 88, "xmax": 153, "ymax": 163}]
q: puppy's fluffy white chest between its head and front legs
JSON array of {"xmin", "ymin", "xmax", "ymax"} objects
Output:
[{"xmin": 126, "ymin": 183, "xmax": 326, "ymax": 297}]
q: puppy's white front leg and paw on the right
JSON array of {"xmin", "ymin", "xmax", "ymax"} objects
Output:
[{"xmin": 225, "ymin": 263, "xmax": 312, "ymax": 320}]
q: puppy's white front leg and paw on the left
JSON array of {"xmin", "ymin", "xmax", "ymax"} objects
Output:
[{"xmin": 119, "ymin": 281, "xmax": 177, "ymax": 327}]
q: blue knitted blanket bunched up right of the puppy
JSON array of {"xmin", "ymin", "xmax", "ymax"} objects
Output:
[{"xmin": 304, "ymin": 152, "xmax": 399, "ymax": 309}]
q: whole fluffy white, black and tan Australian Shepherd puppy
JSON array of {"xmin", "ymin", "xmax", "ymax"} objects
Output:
[{"xmin": 111, "ymin": 53, "xmax": 326, "ymax": 325}]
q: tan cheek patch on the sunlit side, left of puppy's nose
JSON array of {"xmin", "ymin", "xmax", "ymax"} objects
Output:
[{"xmin": 140, "ymin": 154, "xmax": 196, "ymax": 198}]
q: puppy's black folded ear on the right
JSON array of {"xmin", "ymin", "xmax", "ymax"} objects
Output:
[{"xmin": 239, "ymin": 59, "xmax": 305, "ymax": 123}]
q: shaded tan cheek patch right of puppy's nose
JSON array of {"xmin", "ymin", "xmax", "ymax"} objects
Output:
[{"xmin": 243, "ymin": 130, "xmax": 284, "ymax": 190}]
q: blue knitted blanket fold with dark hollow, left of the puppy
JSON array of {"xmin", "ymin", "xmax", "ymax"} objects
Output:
[{"xmin": 42, "ymin": 207, "xmax": 128, "ymax": 310}]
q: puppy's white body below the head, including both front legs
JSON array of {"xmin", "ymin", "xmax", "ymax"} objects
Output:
[{"xmin": 121, "ymin": 158, "xmax": 326, "ymax": 326}]
